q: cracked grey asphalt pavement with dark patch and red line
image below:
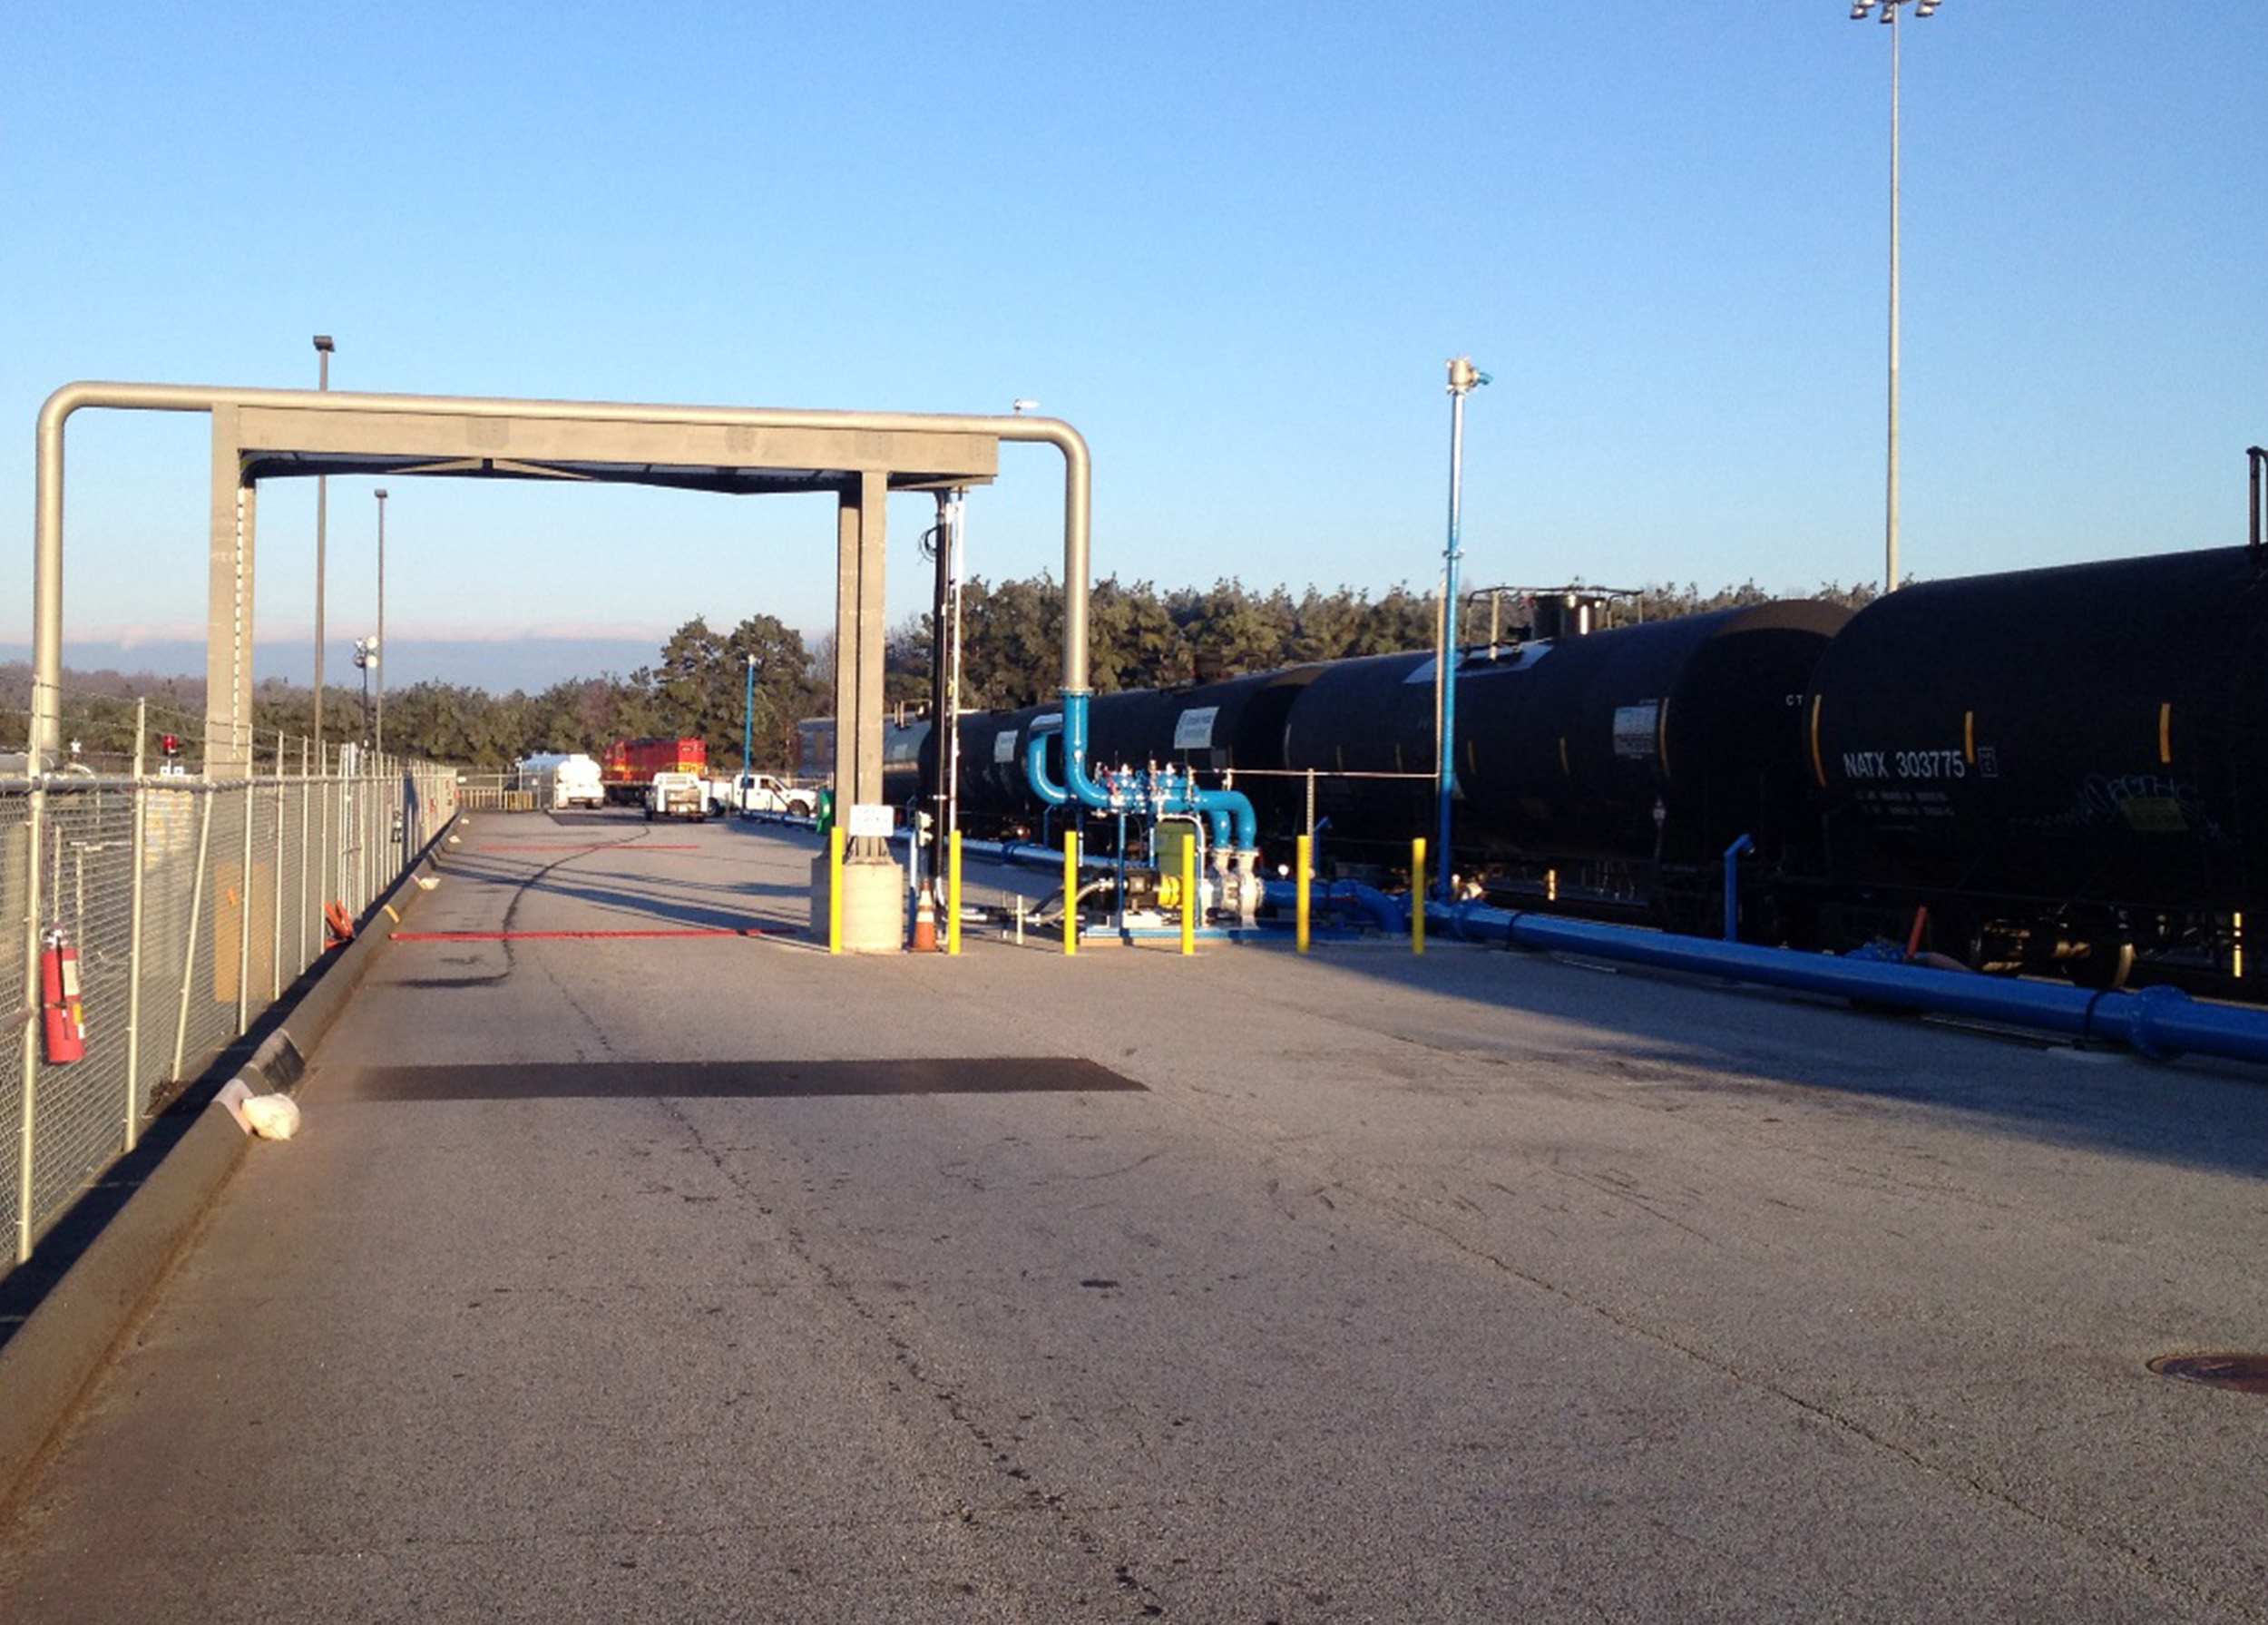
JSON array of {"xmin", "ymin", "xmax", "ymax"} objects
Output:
[{"xmin": 0, "ymin": 815, "xmax": 2268, "ymax": 1625}]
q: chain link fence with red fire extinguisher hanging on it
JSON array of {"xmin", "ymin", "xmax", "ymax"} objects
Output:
[{"xmin": 0, "ymin": 703, "xmax": 458, "ymax": 1273}]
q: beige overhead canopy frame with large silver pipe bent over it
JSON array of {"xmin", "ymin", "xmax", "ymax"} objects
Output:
[{"xmin": 23, "ymin": 381, "xmax": 1091, "ymax": 1155}]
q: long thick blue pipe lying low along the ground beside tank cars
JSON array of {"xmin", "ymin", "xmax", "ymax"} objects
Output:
[{"xmin": 1427, "ymin": 904, "xmax": 2268, "ymax": 1062}]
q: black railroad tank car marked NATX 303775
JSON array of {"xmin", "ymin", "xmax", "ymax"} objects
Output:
[{"xmin": 1808, "ymin": 547, "xmax": 2268, "ymax": 940}]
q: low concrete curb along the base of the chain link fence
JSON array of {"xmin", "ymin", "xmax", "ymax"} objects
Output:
[{"xmin": 0, "ymin": 824, "xmax": 456, "ymax": 1518}]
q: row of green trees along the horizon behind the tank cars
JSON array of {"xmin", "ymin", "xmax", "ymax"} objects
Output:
[{"xmin": 0, "ymin": 576, "xmax": 1873, "ymax": 771}]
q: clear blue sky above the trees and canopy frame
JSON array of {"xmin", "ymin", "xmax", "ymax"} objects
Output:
[{"xmin": 0, "ymin": 0, "xmax": 2268, "ymax": 679}]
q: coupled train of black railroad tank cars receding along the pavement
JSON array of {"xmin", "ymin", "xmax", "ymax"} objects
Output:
[{"xmin": 912, "ymin": 547, "xmax": 2268, "ymax": 990}]
